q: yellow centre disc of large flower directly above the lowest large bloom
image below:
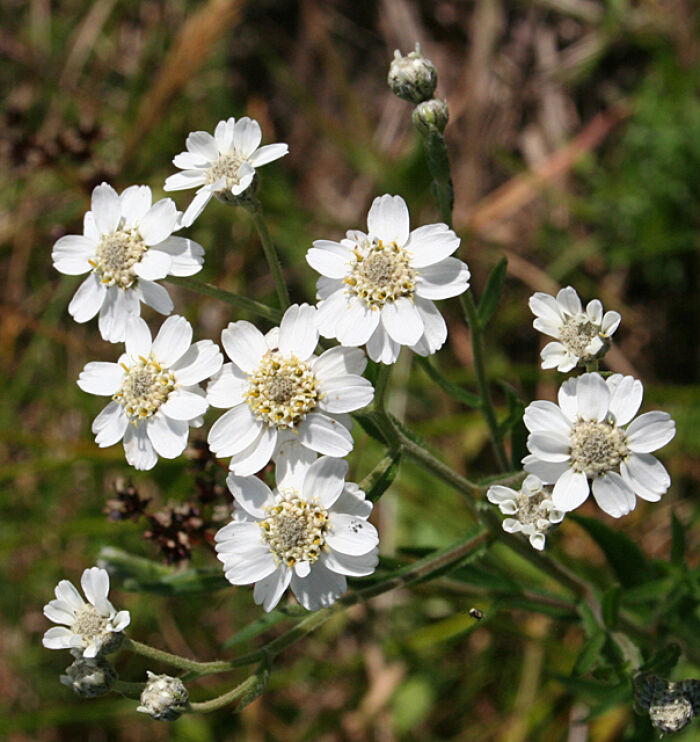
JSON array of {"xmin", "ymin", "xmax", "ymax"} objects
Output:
[{"xmin": 244, "ymin": 351, "xmax": 319, "ymax": 428}]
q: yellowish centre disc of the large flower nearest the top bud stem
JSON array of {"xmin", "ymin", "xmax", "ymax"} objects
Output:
[{"xmin": 345, "ymin": 239, "xmax": 416, "ymax": 309}]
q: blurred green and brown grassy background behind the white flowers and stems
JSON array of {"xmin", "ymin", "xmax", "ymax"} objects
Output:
[{"xmin": 0, "ymin": 0, "xmax": 700, "ymax": 742}]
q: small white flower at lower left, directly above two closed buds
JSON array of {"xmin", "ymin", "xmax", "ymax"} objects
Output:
[{"xmin": 42, "ymin": 567, "xmax": 131, "ymax": 658}]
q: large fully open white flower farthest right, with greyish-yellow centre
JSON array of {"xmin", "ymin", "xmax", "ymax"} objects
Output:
[{"xmin": 523, "ymin": 373, "xmax": 676, "ymax": 518}]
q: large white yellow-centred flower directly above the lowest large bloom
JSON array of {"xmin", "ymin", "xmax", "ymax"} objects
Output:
[{"xmin": 207, "ymin": 304, "xmax": 374, "ymax": 476}]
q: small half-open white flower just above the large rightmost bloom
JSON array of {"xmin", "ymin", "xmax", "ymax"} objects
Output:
[{"xmin": 528, "ymin": 286, "xmax": 621, "ymax": 372}]
